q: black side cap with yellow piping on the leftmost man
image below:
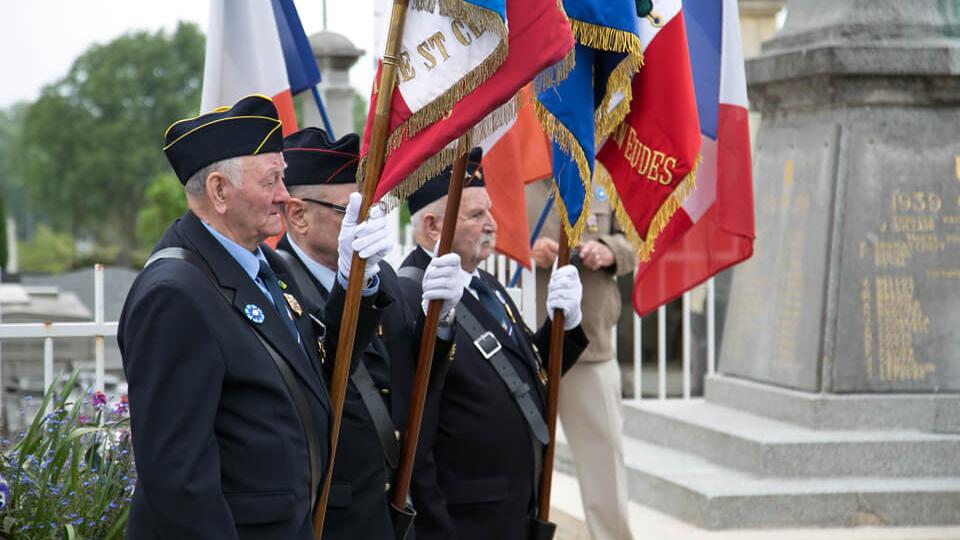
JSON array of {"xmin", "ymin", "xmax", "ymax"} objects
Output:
[{"xmin": 163, "ymin": 94, "xmax": 283, "ymax": 184}]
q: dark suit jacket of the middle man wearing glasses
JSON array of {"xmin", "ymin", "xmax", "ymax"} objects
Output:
[{"xmin": 277, "ymin": 236, "xmax": 452, "ymax": 540}]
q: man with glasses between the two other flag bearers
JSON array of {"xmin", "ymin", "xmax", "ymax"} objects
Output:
[{"xmin": 277, "ymin": 128, "xmax": 463, "ymax": 540}]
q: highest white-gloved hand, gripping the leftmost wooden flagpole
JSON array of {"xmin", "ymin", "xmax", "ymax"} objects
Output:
[{"xmin": 337, "ymin": 192, "xmax": 393, "ymax": 281}]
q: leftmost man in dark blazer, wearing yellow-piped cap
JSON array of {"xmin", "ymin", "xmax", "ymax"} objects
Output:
[{"xmin": 118, "ymin": 96, "xmax": 389, "ymax": 540}]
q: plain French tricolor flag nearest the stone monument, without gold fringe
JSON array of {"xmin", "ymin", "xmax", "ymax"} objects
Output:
[{"xmin": 634, "ymin": 0, "xmax": 754, "ymax": 314}]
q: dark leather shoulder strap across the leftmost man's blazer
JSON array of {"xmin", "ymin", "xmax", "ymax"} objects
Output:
[{"xmin": 143, "ymin": 247, "xmax": 323, "ymax": 508}]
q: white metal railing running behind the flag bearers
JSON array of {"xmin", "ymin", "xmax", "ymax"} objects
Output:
[{"xmin": 0, "ymin": 245, "xmax": 716, "ymax": 400}]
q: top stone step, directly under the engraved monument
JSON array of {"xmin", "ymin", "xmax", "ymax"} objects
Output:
[{"xmin": 704, "ymin": 374, "xmax": 960, "ymax": 433}]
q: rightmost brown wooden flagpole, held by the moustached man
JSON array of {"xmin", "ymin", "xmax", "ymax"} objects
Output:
[{"xmin": 537, "ymin": 227, "xmax": 570, "ymax": 521}]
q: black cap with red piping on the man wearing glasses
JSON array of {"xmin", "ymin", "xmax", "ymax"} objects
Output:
[{"xmin": 283, "ymin": 128, "xmax": 360, "ymax": 186}]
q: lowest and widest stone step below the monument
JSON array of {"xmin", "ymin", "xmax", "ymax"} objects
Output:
[{"xmin": 557, "ymin": 437, "xmax": 960, "ymax": 530}]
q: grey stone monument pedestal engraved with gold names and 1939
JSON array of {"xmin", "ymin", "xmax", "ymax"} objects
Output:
[{"xmin": 720, "ymin": 0, "xmax": 960, "ymax": 393}]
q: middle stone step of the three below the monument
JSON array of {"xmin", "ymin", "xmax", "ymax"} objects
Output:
[{"xmin": 624, "ymin": 399, "xmax": 960, "ymax": 478}]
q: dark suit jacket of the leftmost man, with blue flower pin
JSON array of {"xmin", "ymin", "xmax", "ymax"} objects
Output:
[{"xmin": 118, "ymin": 212, "xmax": 383, "ymax": 540}]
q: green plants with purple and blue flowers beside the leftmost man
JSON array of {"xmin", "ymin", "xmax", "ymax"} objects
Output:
[{"xmin": 0, "ymin": 372, "xmax": 135, "ymax": 540}]
